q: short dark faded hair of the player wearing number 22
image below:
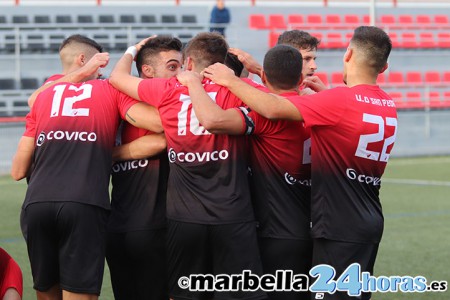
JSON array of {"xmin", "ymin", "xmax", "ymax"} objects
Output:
[{"xmin": 350, "ymin": 26, "xmax": 392, "ymax": 73}]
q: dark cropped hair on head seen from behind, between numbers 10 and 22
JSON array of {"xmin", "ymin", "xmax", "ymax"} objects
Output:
[{"xmin": 263, "ymin": 45, "xmax": 303, "ymax": 90}]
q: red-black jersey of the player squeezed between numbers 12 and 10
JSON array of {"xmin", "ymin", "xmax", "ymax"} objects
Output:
[{"xmin": 108, "ymin": 122, "xmax": 169, "ymax": 232}]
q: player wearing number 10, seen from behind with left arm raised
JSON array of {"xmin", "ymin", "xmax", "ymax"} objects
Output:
[{"xmin": 110, "ymin": 32, "xmax": 266, "ymax": 299}]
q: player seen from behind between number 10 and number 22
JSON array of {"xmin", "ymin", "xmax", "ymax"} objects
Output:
[{"xmin": 177, "ymin": 45, "xmax": 312, "ymax": 300}]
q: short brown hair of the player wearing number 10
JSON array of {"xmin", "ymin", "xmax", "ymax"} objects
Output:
[{"xmin": 184, "ymin": 32, "xmax": 229, "ymax": 68}]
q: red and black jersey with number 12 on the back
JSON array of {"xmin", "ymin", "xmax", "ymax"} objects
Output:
[{"xmin": 24, "ymin": 80, "xmax": 137, "ymax": 209}]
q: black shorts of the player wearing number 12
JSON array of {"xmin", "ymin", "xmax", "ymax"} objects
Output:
[{"xmin": 21, "ymin": 202, "xmax": 109, "ymax": 295}]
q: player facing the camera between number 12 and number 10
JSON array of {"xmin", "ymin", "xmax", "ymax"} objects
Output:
[{"xmin": 106, "ymin": 36, "xmax": 182, "ymax": 300}]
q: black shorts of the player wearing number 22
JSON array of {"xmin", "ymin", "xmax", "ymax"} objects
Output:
[{"xmin": 312, "ymin": 239, "xmax": 379, "ymax": 300}]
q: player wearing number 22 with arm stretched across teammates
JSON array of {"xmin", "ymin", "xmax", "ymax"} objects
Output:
[{"xmin": 204, "ymin": 26, "xmax": 397, "ymax": 300}]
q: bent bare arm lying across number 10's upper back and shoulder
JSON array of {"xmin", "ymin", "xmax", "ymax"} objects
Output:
[{"xmin": 177, "ymin": 71, "xmax": 245, "ymax": 134}]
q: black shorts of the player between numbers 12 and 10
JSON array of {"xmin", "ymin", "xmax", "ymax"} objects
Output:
[{"xmin": 106, "ymin": 228, "xmax": 169, "ymax": 300}]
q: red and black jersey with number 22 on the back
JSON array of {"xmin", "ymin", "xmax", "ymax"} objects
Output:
[{"xmin": 291, "ymin": 85, "xmax": 397, "ymax": 243}]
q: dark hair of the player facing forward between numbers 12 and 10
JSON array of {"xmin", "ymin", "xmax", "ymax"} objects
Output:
[{"xmin": 136, "ymin": 35, "xmax": 183, "ymax": 76}]
